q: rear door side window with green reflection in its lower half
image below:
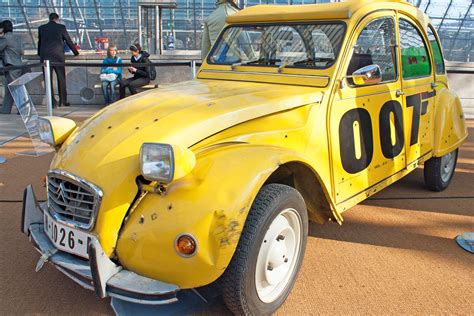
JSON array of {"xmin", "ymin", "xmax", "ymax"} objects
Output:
[{"xmin": 399, "ymin": 19, "xmax": 431, "ymax": 79}]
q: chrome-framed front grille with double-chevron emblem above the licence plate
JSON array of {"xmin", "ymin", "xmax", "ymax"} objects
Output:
[{"xmin": 48, "ymin": 170, "xmax": 102, "ymax": 230}]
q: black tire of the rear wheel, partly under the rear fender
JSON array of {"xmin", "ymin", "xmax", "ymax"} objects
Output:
[{"xmin": 424, "ymin": 149, "xmax": 458, "ymax": 192}]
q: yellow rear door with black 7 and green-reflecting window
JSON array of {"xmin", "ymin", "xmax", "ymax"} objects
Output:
[{"xmin": 398, "ymin": 14, "xmax": 436, "ymax": 168}]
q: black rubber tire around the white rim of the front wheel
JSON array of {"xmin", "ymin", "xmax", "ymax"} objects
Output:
[{"xmin": 222, "ymin": 184, "xmax": 308, "ymax": 315}]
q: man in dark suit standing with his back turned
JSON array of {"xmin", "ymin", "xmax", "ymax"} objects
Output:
[{"xmin": 38, "ymin": 13, "xmax": 79, "ymax": 106}]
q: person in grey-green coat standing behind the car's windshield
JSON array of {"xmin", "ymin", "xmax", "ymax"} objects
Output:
[{"xmin": 201, "ymin": 0, "xmax": 240, "ymax": 60}]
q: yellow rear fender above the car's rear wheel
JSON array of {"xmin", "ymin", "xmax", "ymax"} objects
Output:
[{"xmin": 433, "ymin": 89, "xmax": 467, "ymax": 157}]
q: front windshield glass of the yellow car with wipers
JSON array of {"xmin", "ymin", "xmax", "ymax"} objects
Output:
[{"xmin": 208, "ymin": 23, "xmax": 345, "ymax": 69}]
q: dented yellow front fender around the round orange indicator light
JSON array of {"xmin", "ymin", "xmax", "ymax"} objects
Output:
[{"xmin": 117, "ymin": 144, "xmax": 314, "ymax": 288}]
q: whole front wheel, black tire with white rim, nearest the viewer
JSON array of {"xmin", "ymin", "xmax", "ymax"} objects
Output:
[{"xmin": 222, "ymin": 184, "xmax": 308, "ymax": 315}]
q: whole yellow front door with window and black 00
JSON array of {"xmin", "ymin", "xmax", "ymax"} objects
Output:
[{"xmin": 329, "ymin": 11, "xmax": 406, "ymax": 205}]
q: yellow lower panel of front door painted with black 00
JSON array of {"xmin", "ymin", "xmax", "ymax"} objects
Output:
[{"xmin": 330, "ymin": 82, "xmax": 406, "ymax": 203}]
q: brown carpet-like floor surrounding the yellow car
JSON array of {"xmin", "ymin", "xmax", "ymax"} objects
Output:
[{"xmin": 0, "ymin": 112, "xmax": 474, "ymax": 315}]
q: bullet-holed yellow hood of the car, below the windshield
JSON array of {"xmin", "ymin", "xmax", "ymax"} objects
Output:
[{"xmin": 57, "ymin": 80, "xmax": 322, "ymax": 166}]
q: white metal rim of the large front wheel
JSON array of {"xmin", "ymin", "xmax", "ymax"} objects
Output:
[{"xmin": 255, "ymin": 208, "xmax": 302, "ymax": 303}]
